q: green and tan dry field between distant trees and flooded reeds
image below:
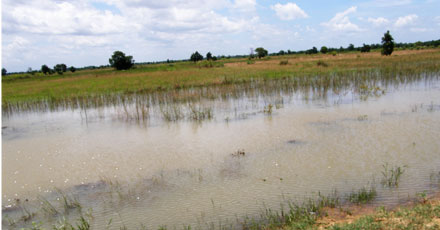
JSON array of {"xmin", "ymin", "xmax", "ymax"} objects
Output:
[{"xmin": 2, "ymin": 49, "xmax": 440, "ymax": 107}]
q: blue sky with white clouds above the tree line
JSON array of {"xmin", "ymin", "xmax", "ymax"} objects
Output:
[{"xmin": 2, "ymin": 0, "xmax": 440, "ymax": 72}]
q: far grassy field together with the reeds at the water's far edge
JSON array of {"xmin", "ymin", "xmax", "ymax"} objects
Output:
[{"xmin": 2, "ymin": 49, "xmax": 440, "ymax": 113}]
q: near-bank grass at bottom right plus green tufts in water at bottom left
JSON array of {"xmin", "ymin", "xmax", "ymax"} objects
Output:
[{"xmin": 4, "ymin": 178, "xmax": 440, "ymax": 230}]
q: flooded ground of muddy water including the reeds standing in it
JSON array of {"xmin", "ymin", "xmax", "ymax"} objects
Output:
[{"xmin": 2, "ymin": 52, "xmax": 440, "ymax": 229}]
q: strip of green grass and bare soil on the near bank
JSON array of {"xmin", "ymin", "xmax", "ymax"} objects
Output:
[{"xmin": 15, "ymin": 199, "xmax": 440, "ymax": 230}]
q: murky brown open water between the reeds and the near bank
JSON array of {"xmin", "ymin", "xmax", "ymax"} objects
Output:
[{"xmin": 2, "ymin": 81, "xmax": 440, "ymax": 229}]
